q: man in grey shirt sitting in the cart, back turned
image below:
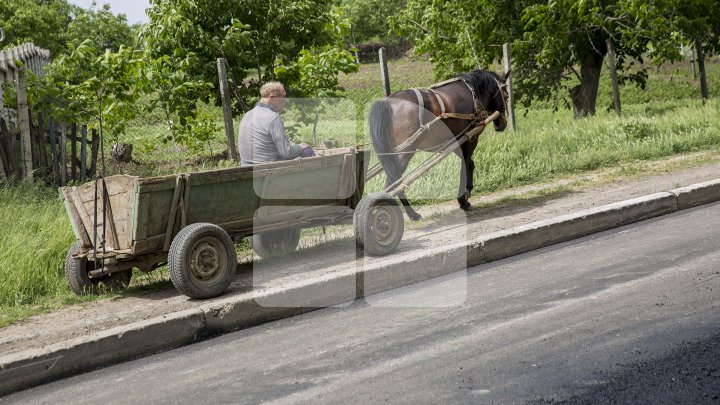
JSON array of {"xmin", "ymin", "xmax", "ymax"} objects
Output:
[{"xmin": 238, "ymin": 82, "xmax": 315, "ymax": 166}]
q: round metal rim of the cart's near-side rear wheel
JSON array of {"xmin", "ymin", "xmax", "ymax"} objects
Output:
[{"xmin": 190, "ymin": 236, "xmax": 228, "ymax": 285}]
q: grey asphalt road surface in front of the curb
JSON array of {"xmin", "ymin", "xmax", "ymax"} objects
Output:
[{"xmin": 0, "ymin": 204, "xmax": 720, "ymax": 404}]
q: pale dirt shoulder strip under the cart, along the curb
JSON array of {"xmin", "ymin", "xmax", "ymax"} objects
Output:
[{"xmin": 0, "ymin": 152, "xmax": 720, "ymax": 355}]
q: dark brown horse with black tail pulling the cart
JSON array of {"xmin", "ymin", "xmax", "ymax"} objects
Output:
[{"xmin": 368, "ymin": 70, "xmax": 507, "ymax": 220}]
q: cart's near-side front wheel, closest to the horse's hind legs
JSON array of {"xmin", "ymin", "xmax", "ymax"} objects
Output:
[{"xmin": 353, "ymin": 193, "xmax": 405, "ymax": 256}]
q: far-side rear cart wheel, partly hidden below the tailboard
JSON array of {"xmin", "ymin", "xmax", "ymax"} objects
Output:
[{"xmin": 65, "ymin": 242, "xmax": 132, "ymax": 295}]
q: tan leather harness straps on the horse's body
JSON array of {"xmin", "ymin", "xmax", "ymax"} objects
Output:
[{"xmin": 395, "ymin": 77, "xmax": 490, "ymax": 152}]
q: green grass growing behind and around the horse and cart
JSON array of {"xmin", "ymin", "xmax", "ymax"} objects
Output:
[{"xmin": 0, "ymin": 57, "xmax": 720, "ymax": 327}]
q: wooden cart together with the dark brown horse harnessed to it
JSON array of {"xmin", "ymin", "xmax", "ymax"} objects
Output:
[{"xmin": 62, "ymin": 70, "xmax": 506, "ymax": 298}]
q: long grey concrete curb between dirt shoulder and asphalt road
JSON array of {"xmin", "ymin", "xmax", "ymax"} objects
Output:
[{"xmin": 0, "ymin": 179, "xmax": 720, "ymax": 395}]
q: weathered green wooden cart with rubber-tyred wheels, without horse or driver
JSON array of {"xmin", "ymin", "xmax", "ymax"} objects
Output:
[{"xmin": 61, "ymin": 148, "xmax": 404, "ymax": 298}]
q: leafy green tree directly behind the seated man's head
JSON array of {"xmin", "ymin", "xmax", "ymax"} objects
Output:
[{"xmin": 140, "ymin": 0, "xmax": 358, "ymax": 109}]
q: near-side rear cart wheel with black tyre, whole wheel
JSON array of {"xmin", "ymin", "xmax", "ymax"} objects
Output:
[{"xmin": 168, "ymin": 223, "xmax": 237, "ymax": 298}]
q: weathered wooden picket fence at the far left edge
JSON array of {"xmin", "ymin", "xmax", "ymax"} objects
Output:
[{"xmin": 0, "ymin": 43, "xmax": 100, "ymax": 185}]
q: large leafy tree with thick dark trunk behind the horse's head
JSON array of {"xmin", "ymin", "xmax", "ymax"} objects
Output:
[{"xmin": 391, "ymin": 0, "xmax": 684, "ymax": 117}]
